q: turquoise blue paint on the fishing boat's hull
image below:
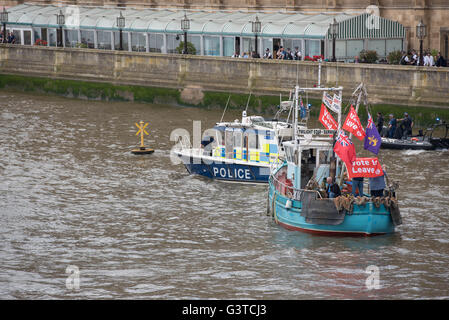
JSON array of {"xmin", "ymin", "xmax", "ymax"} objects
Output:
[{"xmin": 269, "ymin": 183, "xmax": 395, "ymax": 236}]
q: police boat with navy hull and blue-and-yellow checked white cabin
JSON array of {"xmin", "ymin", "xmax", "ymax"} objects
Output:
[{"xmin": 174, "ymin": 100, "xmax": 306, "ymax": 183}]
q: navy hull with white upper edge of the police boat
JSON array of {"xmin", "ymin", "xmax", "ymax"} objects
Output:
[{"xmin": 175, "ymin": 151, "xmax": 270, "ymax": 183}]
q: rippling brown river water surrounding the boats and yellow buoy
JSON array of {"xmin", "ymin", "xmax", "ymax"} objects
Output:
[{"xmin": 0, "ymin": 91, "xmax": 449, "ymax": 299}]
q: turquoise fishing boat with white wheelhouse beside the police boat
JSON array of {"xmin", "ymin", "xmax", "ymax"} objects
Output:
[{"xmin": 267, "ymin": 88, "xmax": 402, "ymax": 236}]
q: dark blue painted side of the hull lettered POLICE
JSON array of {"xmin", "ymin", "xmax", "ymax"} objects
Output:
[{"xmin": 180, "ymin": 159, "xmax": 270, "ymax": 183}]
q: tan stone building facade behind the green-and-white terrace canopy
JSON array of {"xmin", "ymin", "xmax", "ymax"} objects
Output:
[{"xmin": 3, "ymin": 0, "xmax": 449, "ymax": 57}]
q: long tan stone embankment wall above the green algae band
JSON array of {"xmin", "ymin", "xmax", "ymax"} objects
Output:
[{"xmin": 0, "ymin": 44, "xmax": 449, "ymax": 107}]
